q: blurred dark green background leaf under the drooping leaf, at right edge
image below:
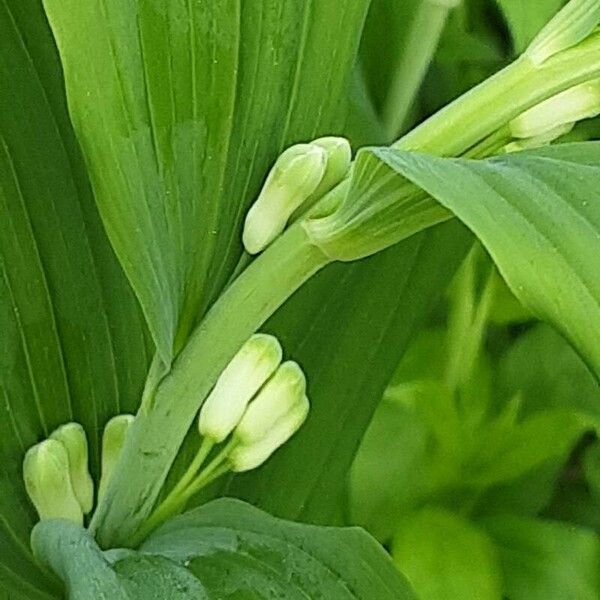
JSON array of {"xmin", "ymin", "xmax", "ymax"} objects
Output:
[{"xmin": 498, "ymin": 325, "xmax": 600, "ymax": 416}]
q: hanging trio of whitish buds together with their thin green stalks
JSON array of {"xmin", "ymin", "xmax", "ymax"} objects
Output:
[{"xmin": 137, "ymin": 333, "xmax": 310, "ymax": 539}]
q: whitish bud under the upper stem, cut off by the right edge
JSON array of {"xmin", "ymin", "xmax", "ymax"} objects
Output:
[{"xmin": 510, "ymin": 79, "xmax": 600, "ymax": 139}]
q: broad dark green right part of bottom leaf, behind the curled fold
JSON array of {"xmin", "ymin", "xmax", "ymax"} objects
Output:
[{"xmin": 140, "ymin": 499, "xmax": 414, "ymax": 600}]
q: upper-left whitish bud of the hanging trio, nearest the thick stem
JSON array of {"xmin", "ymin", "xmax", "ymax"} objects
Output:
[{"xmin": 198, "ymin": 333, "xmax": 283, "ymax": 443}]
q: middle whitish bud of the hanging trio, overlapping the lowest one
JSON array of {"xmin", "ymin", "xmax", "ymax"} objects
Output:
[{"xmin": 233, "ymin": 360, "xmax": 306, "ymax": 445}]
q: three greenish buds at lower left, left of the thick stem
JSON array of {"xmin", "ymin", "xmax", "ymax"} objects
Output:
[{"xmin": 23, "ymin": 415, "xmax": 133, "ymax": 524}]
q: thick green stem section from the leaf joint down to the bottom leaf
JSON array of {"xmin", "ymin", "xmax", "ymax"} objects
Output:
[{"xmin": 90, "ymin": 225, "xmax": 330, "ymax": 547}]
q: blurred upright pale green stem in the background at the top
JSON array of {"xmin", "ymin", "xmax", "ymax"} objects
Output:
[{"xmin": 381, "ymin": 0, "xmax": 452, "ymax": 140}]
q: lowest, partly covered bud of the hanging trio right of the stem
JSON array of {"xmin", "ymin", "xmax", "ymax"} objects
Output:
[{"xmin": 228, "ymin": 396, "xmax": 310, "ymax": 473}]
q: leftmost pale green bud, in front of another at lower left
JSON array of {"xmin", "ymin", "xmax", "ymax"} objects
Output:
[{"xmin": 23, "ymin": 439, "xmax": 83, "ymax": 525}]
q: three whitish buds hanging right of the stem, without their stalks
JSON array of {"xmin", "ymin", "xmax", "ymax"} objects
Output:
[{"xmin": 198, "ymin": 334, "xmax": 309, "ymax": 472}]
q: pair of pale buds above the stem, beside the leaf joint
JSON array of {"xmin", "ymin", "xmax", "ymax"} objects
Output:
[{"xmin": 242, "ymin": 136, "xmax": 352, "ymax": 254}]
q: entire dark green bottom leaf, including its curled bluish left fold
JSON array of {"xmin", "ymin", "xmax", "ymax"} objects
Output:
[{"xmin": 32, "ymin": 500, "xmax": 414, "ymax": 600}]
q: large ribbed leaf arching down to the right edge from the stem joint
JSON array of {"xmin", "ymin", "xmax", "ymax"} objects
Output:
[{"xmin": 364, "ymin": 142, "xmax": 600, "ymax": 377}]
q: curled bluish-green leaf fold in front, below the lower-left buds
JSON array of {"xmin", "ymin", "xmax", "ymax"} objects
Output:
[{"xmin": 31, "ymin": 520, "xmax": 209, "ymax": 600}]
